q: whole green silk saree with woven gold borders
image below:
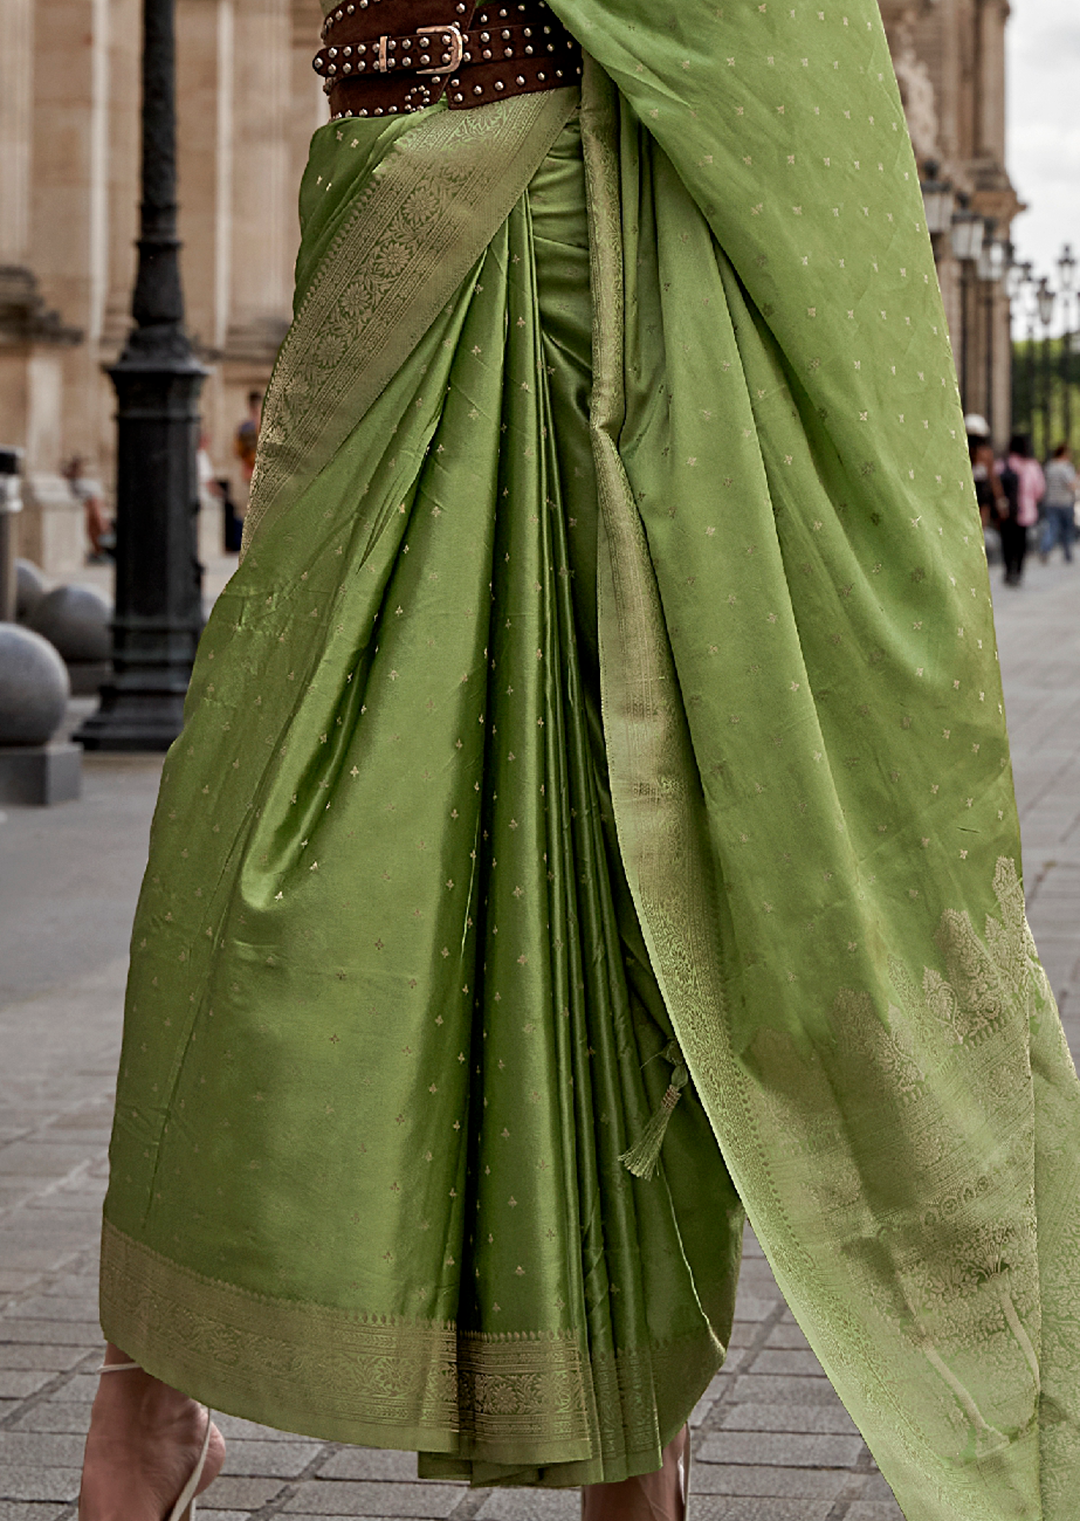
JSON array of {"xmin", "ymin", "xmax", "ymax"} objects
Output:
[{"xmin": 102, "ymin": 0, "xmax": 1080, "ymax": 1521}]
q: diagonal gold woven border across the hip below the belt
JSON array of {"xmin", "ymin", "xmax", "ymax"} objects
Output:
[{"xmin": 243, "ymin": 88, "xmax": 578, "ymax": 552}]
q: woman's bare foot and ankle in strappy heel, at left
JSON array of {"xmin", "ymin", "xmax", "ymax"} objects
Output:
[{"xmin": 79, "ymin": 1342, "xmax": 225, "ymax": 1521}]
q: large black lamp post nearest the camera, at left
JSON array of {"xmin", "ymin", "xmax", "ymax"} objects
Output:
[{"xmin": 76, "ymin": 0, "xmax": 207, "ymax": 750}]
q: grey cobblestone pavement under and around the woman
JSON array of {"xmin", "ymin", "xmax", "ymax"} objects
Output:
[{"xmin": 0, "ymin": 564, "xmax": 1080, "ymax": 1521}]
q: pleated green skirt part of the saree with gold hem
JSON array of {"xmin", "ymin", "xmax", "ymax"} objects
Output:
[{"xmin": 102, "ymin": 107, "xmax": 742, "ymax": 1484}]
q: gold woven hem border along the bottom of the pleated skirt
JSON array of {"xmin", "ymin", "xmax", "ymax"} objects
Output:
[{"xmin": 100, "ymin": 1221, "xmax": 723, "ymax": 1483}]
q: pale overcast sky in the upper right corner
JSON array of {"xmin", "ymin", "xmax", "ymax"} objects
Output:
[{"xmin": 1007, "ymin": 0, "xmax": 1080, "ymax": 317}]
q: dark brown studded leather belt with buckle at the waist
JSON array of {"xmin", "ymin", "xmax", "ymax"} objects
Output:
[{"xmin": 313, "ymin": 0, "xmax": 581, "ymax": 120}]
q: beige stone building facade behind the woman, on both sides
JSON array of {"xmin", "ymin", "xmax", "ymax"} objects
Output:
[{"xmin": 0, "ymin": 0, "xmax": 1018, "ymax": 575}]
